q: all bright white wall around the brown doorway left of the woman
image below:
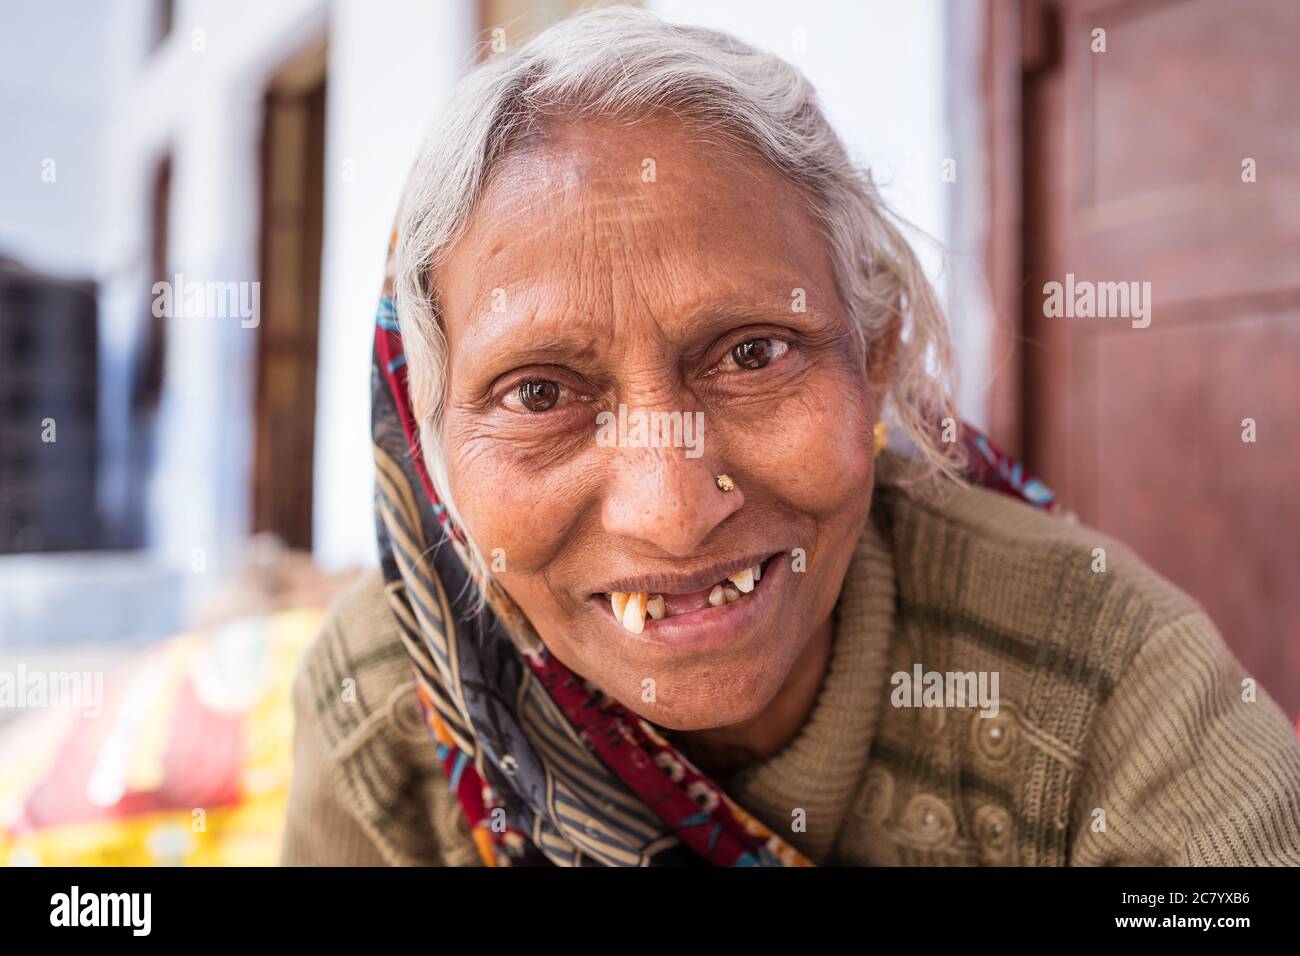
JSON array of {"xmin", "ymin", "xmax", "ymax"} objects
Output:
[{"xmin": 90, "ymin": 0, "xmax": 473, "ymax": 579}]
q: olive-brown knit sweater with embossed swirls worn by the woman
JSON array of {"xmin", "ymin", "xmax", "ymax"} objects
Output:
[{"xmin": 283, "ymin": 455, "xmax": 1300, "ymax": 866}]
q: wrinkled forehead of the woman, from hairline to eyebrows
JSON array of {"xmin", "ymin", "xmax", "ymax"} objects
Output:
[{"xmin": 436, "ymin": 118, "xmax": 831, "ymax": 348}]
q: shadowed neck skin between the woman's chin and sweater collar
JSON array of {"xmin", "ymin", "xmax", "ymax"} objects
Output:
[{"xmin": 672, "ymin": 617, "xmax": 832, "ymax": 775}]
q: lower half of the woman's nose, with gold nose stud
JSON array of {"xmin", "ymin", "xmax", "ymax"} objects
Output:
[{"xmin": 601, "ymin": 447, "xmax": 745, "ymax": 557}]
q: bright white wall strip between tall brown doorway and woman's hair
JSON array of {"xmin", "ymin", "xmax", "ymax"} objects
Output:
[{"xmin": 313, "ymin": 0, "xmax": 476, "ymax": 568}]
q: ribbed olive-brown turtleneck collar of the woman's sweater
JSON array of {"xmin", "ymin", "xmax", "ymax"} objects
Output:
[{"xmin": 719, "ymin": 498, "xmax": 896, "ymax": 864}]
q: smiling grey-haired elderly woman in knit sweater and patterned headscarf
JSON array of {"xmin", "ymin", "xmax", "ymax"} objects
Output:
[{"xmin": 285, "ymin": 10, "xmax": 1300, "ymax": 866}]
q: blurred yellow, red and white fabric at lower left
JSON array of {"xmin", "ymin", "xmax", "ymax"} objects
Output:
[{"xmin": 0, "ymin": 609, "xmax": 324, "ymax": 866}]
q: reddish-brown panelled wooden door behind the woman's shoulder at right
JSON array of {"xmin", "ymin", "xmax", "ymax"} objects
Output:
[{"xmin": 1021, "ymin": 0, "xmax": 1300, "ymax": 718}]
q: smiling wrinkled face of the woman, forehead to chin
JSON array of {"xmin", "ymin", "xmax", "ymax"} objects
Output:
[{"xmin": 436, "ymin": 118, "xmax": 879, "ymax": 730}]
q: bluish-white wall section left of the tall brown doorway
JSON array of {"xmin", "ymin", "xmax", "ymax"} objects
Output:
[{"xmin": 100, "ymin": 0, "xmax": 328, "ymax": 589}]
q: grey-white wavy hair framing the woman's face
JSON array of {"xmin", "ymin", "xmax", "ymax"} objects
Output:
[{"xmin": 395, "ymin": 7, "xmax": 959, "ymax": 590}]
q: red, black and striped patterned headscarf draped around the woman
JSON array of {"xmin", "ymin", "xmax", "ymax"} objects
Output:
[{"xmin": 371, "ymin": 234, "xmax": 1053, "ymax": 866}]
